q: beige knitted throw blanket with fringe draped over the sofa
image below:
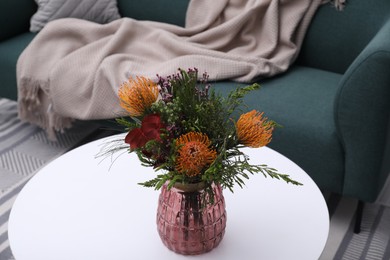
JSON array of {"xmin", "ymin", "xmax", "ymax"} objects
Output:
[{"xmin": 17, "ymin": 0, "xmax": 324, "ymax": 137}]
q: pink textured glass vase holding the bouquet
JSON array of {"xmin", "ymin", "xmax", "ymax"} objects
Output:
[{"xmin": 157, "ymin": 184, "xmax": 226, "ymax": 255}]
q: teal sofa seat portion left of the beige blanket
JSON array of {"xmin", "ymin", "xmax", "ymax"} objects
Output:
[{"xmin": 0, "ymin": 32, "xmax": 36, "ymax": 100}]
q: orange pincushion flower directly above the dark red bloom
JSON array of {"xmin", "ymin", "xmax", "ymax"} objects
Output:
[{"xmin": 118, "ymin": 77, "xmax": 158, "ymax": 116}]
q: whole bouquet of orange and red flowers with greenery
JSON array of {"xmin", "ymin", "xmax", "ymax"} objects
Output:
[{"xmin": 109, "ymin": 69, "xmax": 300, "ymax": 196}]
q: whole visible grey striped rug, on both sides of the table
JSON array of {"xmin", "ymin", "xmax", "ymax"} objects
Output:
[{"xmin": 0, "ymin": 99, "xmax": 390, "ymax": 260}]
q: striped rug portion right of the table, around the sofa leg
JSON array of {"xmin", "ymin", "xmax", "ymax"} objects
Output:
[{"xmin": 320, "ymin": 193, "xmax": 390, "ymax": 260}]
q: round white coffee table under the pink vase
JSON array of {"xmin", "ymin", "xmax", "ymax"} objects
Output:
[{"xmin": 9, "ymin": 134, "xmax": 329, "ymax": 260}]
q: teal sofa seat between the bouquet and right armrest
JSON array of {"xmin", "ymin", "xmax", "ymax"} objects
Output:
[{"xmin": 215, "ymin": 66, "xmax": 344, "ymax": 193}]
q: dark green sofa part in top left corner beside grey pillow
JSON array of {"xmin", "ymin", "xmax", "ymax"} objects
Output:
[{"xmin": 0, "ymin": 0, "xmax": 37, "ymax": 41}]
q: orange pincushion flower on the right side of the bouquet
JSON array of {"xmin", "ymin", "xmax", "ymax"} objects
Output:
[{"xmin": 236, "ymin": 110, "xmax": 274, "ymax": 148}]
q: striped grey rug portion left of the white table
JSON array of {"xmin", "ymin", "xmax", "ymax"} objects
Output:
[{"xmin": 0, "ymin": 98, "xmax": 98, "ymax": 260}]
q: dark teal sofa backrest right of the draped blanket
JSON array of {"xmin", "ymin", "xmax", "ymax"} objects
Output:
[{"xmin": 298, "ymin": 0, "xmax": 390, "ymax": 74}]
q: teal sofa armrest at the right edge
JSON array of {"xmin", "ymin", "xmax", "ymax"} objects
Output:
[{"xmin": 335, "ymin": 19, "xmax": 390, "ymax": 202}]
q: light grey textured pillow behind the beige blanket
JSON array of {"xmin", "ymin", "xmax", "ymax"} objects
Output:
[{"xmin": 30, "ymin": 0, "xmax": 120, "ymax": 32}]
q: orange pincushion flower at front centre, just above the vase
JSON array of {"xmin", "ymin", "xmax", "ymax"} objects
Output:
[{"xmin": 176, "ymin": 132, "xmax": 217, "ymax": 176}]
